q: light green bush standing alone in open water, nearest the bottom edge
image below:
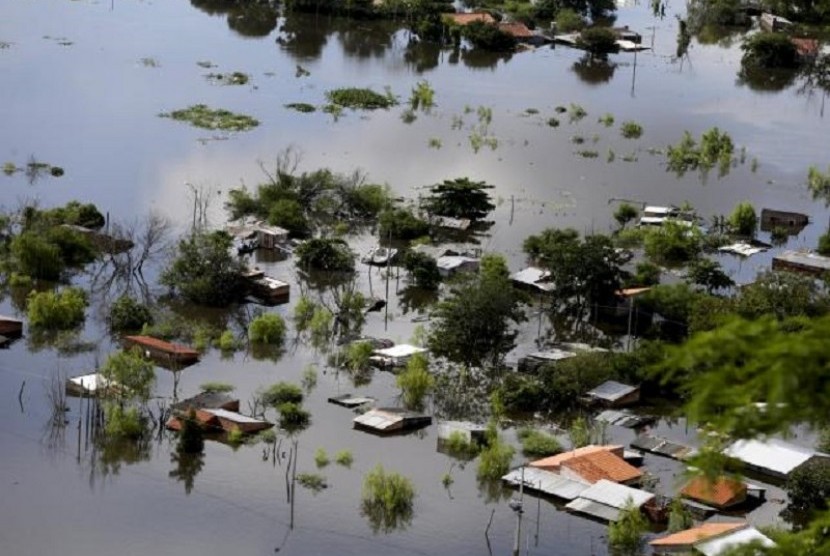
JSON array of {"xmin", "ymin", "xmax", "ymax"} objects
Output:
[{"xmin": 360, "ymin": 465, "xmax": 415, "ymax": 533}]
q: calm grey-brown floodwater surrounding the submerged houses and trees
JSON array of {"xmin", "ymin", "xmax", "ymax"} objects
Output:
[{"xmin": 0, "ymin": 0, "xmax": 830, "ymax": 556}]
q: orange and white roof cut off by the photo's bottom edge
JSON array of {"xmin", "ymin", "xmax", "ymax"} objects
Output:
[{"xmin": 649, "ymin": 521, "xmax": 774, "ymax": 556}]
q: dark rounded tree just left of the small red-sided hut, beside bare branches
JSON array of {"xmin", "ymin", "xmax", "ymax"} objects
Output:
[{"xmin": 159, "ymin": 231, "xmax": 245, "ymax": 307}]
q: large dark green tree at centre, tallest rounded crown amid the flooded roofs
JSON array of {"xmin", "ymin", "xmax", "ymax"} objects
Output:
[{"xmin": 428, "ymin": 270, "xmax": 525, "ymax": 367}]
